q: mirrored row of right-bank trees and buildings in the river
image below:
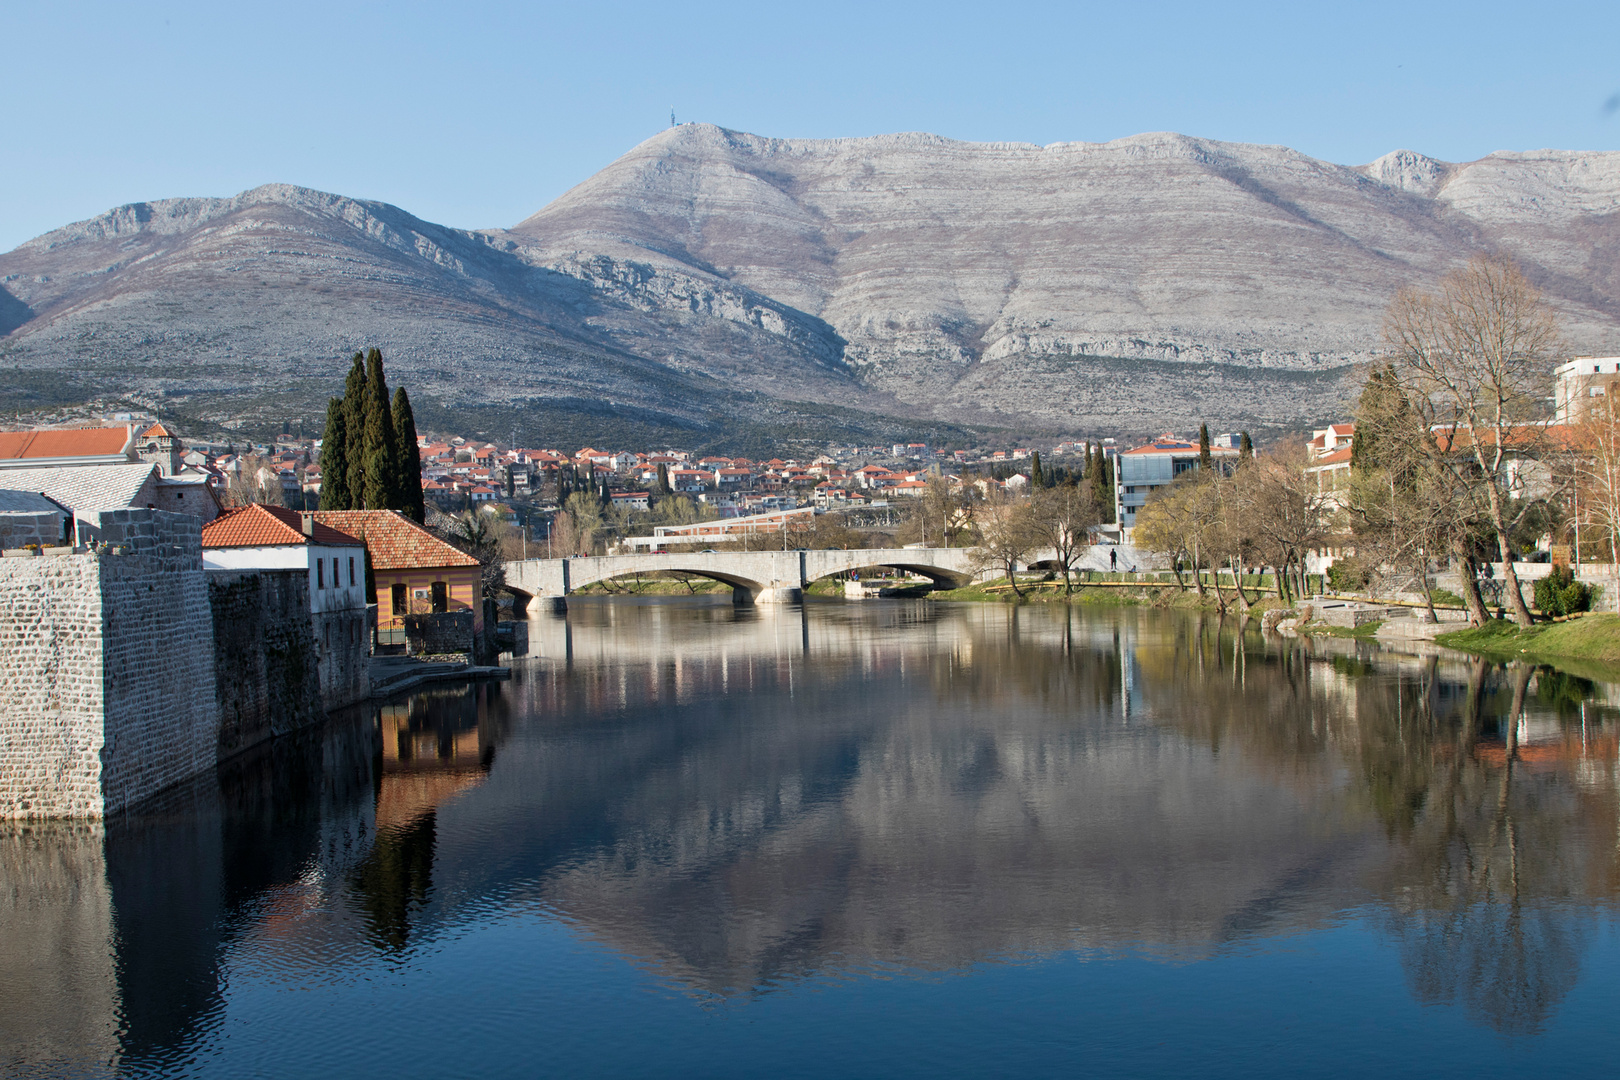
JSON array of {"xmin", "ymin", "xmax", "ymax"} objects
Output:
[{"xmin": 1155, "ymin": 628, "xmax": 1617, "ymax": 1035}]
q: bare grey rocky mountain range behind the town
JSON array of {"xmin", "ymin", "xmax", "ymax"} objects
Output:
[{"xmin": 0, "ymin": 125, "xmax": 1620, "ymax": 439}]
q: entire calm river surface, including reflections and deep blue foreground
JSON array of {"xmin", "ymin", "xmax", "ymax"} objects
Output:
[{"xmin": 0, "ymin": 597, "xmax": 1620, "ymax": 1077}]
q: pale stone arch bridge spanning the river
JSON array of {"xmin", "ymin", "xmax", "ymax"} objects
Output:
[{"xmin": 505, "ymin": 547, "xmax": 1030, "ymax": 607}]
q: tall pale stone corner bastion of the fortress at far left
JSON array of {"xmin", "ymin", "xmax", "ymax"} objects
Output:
[{"xmin": 0, "ymin": 510, "xmax": 219, "ymax": 818}]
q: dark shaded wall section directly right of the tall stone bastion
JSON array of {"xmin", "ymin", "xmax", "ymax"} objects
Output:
[{"xmin": 207, "ymin": 570, "xmax": 324, "ymax": 759}]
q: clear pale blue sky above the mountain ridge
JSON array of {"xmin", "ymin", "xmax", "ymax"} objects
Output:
[{"xmin": 0, "ymin": 0, "xmax": 1620, "ymax": 251}]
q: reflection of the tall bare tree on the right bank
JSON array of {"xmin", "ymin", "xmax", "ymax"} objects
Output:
[{"xmin": 1387, "ymin": 661, "xmax": 1614, "ymax": 1035}]
